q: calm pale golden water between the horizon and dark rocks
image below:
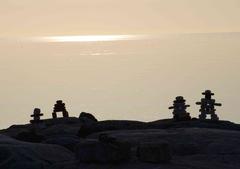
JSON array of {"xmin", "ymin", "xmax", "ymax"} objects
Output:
[{"xmin": 0, "ymin": 33, "xmax": 240, "ymax": 128}]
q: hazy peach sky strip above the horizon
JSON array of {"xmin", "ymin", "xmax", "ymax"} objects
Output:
[{"xmin": 0, "ymin": 0, "xmax": 240, "ymax": 36}]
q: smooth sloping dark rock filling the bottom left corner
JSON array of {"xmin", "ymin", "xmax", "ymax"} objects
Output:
[{"xmin": 0, "ymin": 135, "xmax": 74, "ymax": 169}]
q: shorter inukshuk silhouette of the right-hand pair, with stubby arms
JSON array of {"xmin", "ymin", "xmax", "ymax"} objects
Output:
[{"xmin": 169, "ymin": 96, "xmax": 191, "ymax": 121}]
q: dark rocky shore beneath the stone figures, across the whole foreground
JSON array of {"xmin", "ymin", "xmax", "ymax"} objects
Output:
[{"xmin": 0, "ymin": 116, "xmax": 240, "ymax": 169}]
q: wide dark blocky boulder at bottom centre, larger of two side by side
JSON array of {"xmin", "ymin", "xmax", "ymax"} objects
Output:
[{"xmin": 76, "ymin": 140, "xmax": 130, "ymax": 163}]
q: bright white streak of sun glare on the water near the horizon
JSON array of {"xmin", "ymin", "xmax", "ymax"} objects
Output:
[{"xmin": 37, "ymin": 35, "xmax": 141, "ymax": 42}]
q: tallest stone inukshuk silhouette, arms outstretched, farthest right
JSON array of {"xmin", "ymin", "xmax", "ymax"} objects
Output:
[{"xmin": 196, "ymin": 90, "xmax": 222, "ymax": 120}]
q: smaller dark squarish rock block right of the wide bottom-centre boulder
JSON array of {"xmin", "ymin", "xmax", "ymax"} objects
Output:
[{"xmin": 137, "ymin": 142, "xmax": 171, "ymax": 163}]
